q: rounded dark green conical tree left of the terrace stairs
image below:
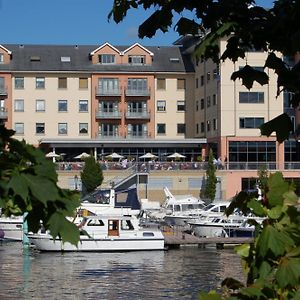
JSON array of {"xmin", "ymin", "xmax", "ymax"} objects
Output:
[{"xmin": 80, "ymin": 156, "xmax": 103, "ymax": 196}]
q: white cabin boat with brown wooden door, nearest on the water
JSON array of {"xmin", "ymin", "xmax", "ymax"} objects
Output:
[{"xmin": 28, "ymin": 215, "xmax": 164, "ymax": 252}]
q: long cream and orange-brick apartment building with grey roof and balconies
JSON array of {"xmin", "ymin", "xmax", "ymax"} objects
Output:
[{"xmin": 0, "ymin": 37, "xmax": 300, "ymax": 198}]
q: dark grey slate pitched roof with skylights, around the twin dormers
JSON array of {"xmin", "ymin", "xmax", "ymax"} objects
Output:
[{"xmin": 0, "ymin": 44, "xmax": 194, "ymax": 73}]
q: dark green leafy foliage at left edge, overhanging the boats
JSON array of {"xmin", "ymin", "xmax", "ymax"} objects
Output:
[{"xmin": 0, "ymin": 125, "xmax": 80, "ymax": 244}]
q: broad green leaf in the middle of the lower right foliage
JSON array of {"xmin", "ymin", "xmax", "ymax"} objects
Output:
[{"xmin": 257, "ymin": 225, "xmax": 294, "ymax": 257}]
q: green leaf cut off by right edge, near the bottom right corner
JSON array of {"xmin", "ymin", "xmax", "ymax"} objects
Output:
[{"xmin": 275, "ymin": 257, "xmax": 300, "ymax": 289}]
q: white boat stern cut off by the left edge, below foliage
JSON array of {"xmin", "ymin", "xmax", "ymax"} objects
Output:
[{"xmin": 0, "ymin": 216, "xmax": 23, "ymax": 241}]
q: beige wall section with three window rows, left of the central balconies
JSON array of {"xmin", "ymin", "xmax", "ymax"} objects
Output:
[{"xmin": 12, "ymin": 73, "xmax": 91, "ymax": 145}]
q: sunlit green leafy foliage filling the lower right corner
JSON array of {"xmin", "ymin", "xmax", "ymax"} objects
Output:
[{"xmin": 199, "ymin": 172, "xmax": 300, "ymax": 299}]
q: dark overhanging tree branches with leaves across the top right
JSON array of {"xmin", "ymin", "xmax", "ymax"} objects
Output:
[{"xmin": 108, "ymin": 0, "xmax": 300, "ymax": 142}]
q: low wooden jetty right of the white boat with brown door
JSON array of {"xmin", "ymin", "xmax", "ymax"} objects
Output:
[{"xmin": 162, "ymin": 231, "xmax": 253, "ymax": 249}]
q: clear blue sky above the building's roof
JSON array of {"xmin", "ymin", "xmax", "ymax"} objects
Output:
[{"xmin": 0, "ymin": 0, "xmax": 273, "ymax": 46}]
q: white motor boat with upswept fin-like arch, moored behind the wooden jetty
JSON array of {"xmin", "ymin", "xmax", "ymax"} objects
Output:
[{"xmin": 147, "ymin": 187, "xmax": 204, "ymax": 225}]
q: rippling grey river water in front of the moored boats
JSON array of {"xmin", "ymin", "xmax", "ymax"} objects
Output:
[{"xmin": 0, "ymin": 243, "xmax": 243, "ymax": 300}]
